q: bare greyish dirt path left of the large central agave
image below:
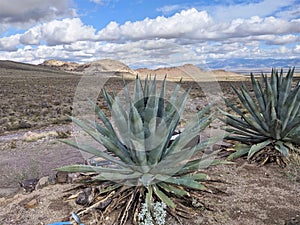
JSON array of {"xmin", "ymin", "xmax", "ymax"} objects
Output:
[{"xmin": 0, "ymin": 125, "xmax": 84, "ymax": 197}]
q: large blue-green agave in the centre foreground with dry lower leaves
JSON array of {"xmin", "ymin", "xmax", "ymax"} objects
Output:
[{"xmin": 58, "ymin": 77, "xmax": 221, "ymax": 224}]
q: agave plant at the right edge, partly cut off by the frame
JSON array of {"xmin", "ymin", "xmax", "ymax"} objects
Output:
[{"xmin": 223, "ymin": 69, "xmax": 300, "ymax": 164}]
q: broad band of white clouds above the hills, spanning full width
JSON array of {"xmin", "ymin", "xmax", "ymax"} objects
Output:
[{"xmin": 0, "ymin": 7, "xmax": 300, "ymax": 66}]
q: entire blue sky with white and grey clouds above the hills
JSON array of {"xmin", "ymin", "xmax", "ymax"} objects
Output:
[{"xmin": 0, "ymin": 0, "xmax": 300, "ymax": 69}]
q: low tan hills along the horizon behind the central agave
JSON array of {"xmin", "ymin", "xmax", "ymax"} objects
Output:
[{"xmin": 0, "ymin": 59, "xmax": 243, "ymax": 81}]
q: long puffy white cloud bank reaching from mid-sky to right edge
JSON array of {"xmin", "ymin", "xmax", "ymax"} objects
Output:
[{"xmin": 98, "ymin": 8, "xmax": 300, "ymax": 43}]
